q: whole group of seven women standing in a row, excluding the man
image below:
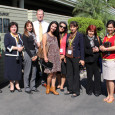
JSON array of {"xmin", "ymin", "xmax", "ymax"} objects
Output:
[{"xmin": 4, "ymin": 20, "xmax": 115, "ymax": 103}]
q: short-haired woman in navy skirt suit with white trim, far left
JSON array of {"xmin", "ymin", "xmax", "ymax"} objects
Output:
[{"xmin": 4, "ymin": 22, "xmax": 23, "ymax": 92}]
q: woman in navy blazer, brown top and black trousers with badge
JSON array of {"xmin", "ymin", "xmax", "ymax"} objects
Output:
[{"xmin": 65, "ymin": 21, "xmax": 84, "ymax": 98}]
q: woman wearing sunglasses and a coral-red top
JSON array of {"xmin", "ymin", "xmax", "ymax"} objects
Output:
[{"xmin": 57, "ymin": 21, "xmax": 67, "ymax": 91}]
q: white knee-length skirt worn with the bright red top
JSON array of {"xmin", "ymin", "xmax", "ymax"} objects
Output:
[{"xmin": 103, "ymin": 60, "xmax": 115, "ymax": 80}]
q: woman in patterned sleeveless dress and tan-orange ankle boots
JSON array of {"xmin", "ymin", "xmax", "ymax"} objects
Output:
[{"xmin": 42, "ymin": 21, "xmax": 61, "ymax": 95}]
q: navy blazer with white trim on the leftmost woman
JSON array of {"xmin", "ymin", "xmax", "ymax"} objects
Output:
[{"xmin": 4, "ymin": 33, "xmax": 23, "ymax": 56}]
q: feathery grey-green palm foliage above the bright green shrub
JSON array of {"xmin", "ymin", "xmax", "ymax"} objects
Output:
[{"xmin": 73, "ymin": 0, "xmax": 113, "ymax": 24}]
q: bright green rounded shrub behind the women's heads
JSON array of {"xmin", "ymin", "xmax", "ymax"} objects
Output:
[{"xmin": 68, "ymin": 17, "xmax": 104, "ymax": 37}]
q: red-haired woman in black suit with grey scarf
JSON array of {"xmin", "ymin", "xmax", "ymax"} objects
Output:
[{"xmin": 84, "ymin": 25, "xmax": 102, "ymax": 96}]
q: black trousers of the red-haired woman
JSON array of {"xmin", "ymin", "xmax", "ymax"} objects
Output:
[{"xmin": 86, "ymin": 61, "xmax": 101, "ymax": 93}]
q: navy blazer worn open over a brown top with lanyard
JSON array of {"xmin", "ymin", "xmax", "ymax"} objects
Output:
[{"xmin": 66, "ymin": 32, "xmax": 84, "ymax": 60}]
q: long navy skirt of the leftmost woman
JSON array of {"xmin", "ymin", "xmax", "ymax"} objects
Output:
[{"xmin": 4, "ymin": 56, "xmax": 22, "ymax": 81}]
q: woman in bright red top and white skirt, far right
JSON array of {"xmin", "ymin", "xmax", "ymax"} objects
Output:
[{"xmin": 100, "ymin": 20, "xmax": 115, "ymax": 103}]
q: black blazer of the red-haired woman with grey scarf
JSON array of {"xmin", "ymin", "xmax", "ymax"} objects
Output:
[{"xmin": 84, "ymin": 35, "xmax": 102, "ymax": 63}]
